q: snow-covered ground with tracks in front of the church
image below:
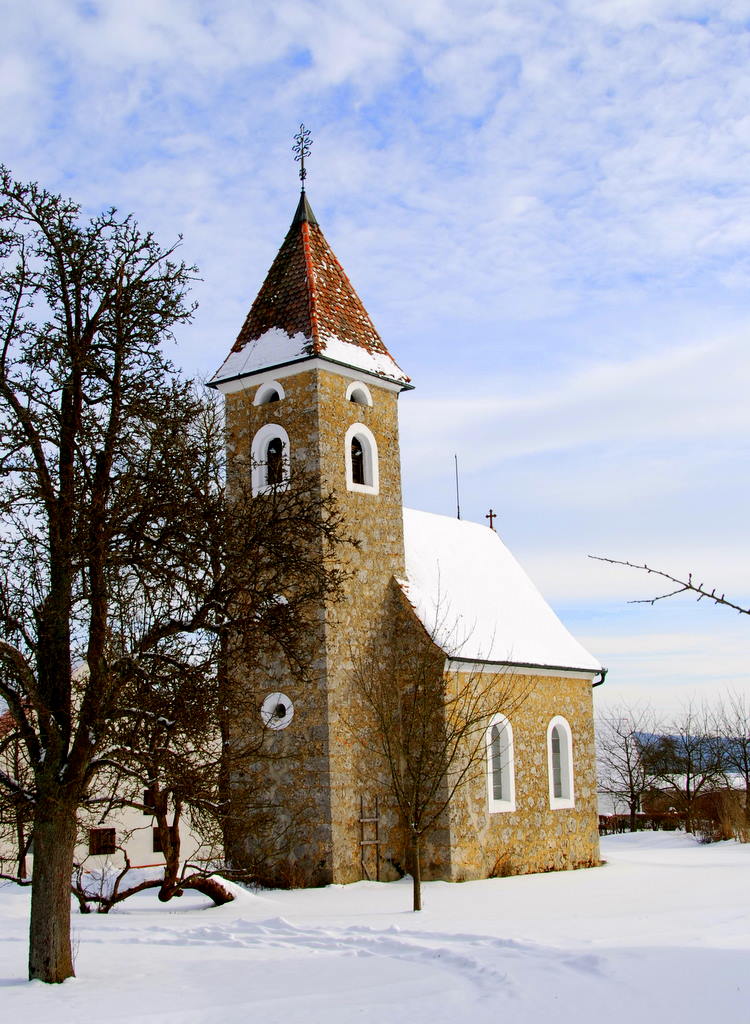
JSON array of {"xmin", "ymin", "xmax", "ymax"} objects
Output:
[{"xmin": 0, "ymin": 833, "xmax": 750, "ymax": 1024}]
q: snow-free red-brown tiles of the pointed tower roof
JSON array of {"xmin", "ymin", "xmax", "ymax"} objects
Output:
[{"xmin": 232, "ymin": 193, "xmax": 408, "ymax": 380}]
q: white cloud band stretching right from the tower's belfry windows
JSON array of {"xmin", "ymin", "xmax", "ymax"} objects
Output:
[{"xmin": 402, "ymin": 323, "xmax": 750, "ymax": 472}]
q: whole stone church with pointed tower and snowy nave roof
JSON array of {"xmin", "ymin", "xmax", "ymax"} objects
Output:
[{"xmin": 210, "ymin": 182, "xmax": 603, "ymax": 885}]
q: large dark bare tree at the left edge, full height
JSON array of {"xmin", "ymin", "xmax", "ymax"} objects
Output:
[{"xmin": 0, "ymin": 169, "xmax": 207, "ymax": 981}]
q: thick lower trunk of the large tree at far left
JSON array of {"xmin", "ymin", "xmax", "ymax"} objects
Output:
[{"xmin": 29, "ymin": 801, "xmax": 76, "ymax": 982}]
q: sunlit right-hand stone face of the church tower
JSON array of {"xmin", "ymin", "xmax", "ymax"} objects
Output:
[{"xmin": 320, "ymin": 372, "xmax": 405, "ymax": 883}]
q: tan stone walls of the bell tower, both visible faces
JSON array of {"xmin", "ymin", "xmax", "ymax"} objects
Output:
[{"xmin": 226, "ymin": 369, "xmax": 404, "ymax": 885}]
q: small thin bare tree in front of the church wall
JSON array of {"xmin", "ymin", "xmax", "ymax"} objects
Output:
[{"xmin": 350, "ymin": 592, "xmax": 530, "ymax": 910}]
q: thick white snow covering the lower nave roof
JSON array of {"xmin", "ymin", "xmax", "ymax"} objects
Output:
[{"xmin": 399, "ymin": 509, "xmax": 601, "ymax": 672}]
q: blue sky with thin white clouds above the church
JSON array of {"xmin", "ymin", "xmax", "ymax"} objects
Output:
[{"xmin": 0, "ymin": 0, "xmax": 750, "ymax": 709}]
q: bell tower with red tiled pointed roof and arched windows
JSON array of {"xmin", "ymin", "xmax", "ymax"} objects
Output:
[{"xmin": 210, "ymin": 144, "xmax": 412, "ymax": 885}]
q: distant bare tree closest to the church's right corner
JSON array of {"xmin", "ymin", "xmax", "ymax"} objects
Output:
[{"xmin": 596, "ymin": 706, "xmax": 655, "ymax": 831}]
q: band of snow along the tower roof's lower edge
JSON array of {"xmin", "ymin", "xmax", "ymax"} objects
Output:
[{"xmin": 209, "ymin": 327, "xmax": 409, "ymax": 384}]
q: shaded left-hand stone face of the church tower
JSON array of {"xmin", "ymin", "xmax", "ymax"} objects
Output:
[{"xmin": 225, "ymin": 373, "xmax": 331, "ymax": 885}]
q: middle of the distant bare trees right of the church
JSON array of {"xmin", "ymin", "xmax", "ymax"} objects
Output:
[{"xmin": 642, "ymin": 705, "xmax": 724, "ymax": 833}]
